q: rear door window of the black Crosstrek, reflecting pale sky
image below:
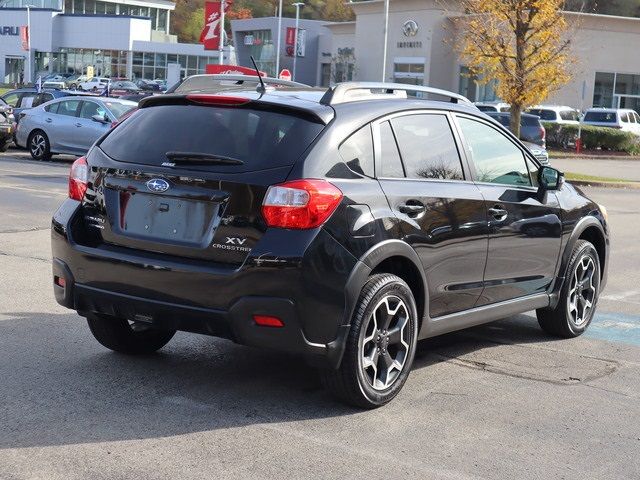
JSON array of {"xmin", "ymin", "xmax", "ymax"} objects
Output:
[{"xmin": 391, "ymin": 114, "xmax": 464, "ymax": 180}]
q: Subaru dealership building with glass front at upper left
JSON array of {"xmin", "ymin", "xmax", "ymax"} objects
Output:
[{"xmin": 0, "ymin": 0, "xmax": 235, "ymax": 84}]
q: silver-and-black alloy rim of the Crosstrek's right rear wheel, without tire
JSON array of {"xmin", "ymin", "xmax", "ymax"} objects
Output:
[{"xmin": 360, "ymin": 295, "xmax": 411, "ymax": 390}]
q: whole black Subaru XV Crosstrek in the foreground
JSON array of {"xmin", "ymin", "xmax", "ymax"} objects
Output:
[{"xmin": 52, "ymin": 83, "xmax": 609, "ymax": 408}]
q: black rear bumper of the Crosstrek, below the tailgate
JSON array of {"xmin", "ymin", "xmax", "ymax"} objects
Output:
[{"xmin": 52, "ymin": 201, "xmax": 359, "ymax": 367}]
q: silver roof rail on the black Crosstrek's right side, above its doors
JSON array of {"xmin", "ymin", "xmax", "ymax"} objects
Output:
[{"xmin": 320, "ymin": 82, "xmax": 473, "ymax": 106}]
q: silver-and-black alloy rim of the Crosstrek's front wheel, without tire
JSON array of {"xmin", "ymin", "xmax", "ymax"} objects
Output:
[{"xmin": 567, "ymin": 255, "xmax": 597, "ymax": 327}]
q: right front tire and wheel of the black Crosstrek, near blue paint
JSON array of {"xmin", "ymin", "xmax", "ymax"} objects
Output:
[{"xmin": 536, "ymin": 240, "xmax": 600, "ymax": 338}]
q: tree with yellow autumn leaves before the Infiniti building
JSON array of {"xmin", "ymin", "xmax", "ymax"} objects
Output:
[{"xmin": 457, "ymin": 0, "xmax": 570, "ymax": 136}]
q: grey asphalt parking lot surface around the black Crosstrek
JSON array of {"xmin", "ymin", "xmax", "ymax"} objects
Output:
[{"xmin": 0, "ymin": 150, "xmax": 640, "ymax": 480}]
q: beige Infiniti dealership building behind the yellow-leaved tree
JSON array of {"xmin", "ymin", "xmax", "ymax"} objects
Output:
[{"xmin": 321, "ymin": 0, "xmax": 640, "ymax": 111}]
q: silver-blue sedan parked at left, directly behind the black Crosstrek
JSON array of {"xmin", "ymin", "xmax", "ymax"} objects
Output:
[{"xmin": 16, "ymin": 97, "xmax": 137, "ymax": 160}]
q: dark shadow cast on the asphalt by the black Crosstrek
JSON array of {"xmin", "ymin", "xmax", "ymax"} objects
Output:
[{"xmin": 0, "ymin": 313, "xmax": 549, "ymax": 449}]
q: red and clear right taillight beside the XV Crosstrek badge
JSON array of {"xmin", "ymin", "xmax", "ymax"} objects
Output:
[{"xmin": 262, "ymin": 180, "xmax": 342, "ymax": 230}]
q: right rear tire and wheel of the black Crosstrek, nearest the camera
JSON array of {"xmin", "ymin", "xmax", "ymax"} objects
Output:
[{"xmin": 321, "ymin": 273, "xmax": 418, "ymax": 408}]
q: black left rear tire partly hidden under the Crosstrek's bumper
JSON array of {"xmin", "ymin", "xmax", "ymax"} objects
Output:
[{"xmin": 87, "ymin": 314, "xmax": 176, "ymax": 355}]
